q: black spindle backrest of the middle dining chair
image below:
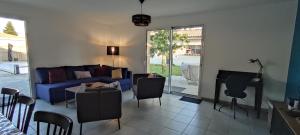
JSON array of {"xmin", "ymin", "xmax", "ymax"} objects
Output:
[{"xmin": 16, "ymin": 95, "xmax": 35, "ymax": 134}]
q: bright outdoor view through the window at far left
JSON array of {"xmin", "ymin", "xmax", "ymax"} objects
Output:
[{"xmin": 0, "ymin": 17, "xmax": 30, "ymax": 95}]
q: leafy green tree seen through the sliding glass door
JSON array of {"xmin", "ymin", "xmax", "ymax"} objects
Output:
[{"xmin": 150, "ymin": 30, "xmax": 190, "ymax": 73}]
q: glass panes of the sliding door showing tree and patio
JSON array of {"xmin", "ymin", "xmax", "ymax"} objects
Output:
[{"xmin": 147, "ymin": 26, "xmax": 203, "ymax": 96}]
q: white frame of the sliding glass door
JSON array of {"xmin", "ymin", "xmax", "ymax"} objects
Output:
[{"xmin": 145, "ymin": 24, "xmax": 205, "ymax": 97}]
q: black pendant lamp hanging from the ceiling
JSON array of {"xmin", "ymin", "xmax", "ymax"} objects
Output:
[{"xmin": 132, "ymin": 0, "xmax": 151, "ymax": 26}]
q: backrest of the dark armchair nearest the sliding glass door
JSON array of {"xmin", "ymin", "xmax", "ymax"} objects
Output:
[{"xmin": 137, "ymin": 75, "xmax": 166, "ymax": 99}]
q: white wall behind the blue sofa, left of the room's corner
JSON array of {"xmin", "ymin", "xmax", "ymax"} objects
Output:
[{"xmin": 0, "ymin": 2, "xmax": 118, "ymax": 94}]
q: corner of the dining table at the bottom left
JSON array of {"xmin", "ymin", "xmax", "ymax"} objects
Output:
[{"xmin": 0, "ymin": 113, "xmax": 25, "ymax": 135}]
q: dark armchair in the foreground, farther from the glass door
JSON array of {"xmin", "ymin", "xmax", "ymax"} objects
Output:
[{"xmin": 76, "ymin": 88, "xmax": 122, "ymax": 135}]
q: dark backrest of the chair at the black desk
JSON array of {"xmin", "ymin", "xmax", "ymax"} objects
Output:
[{"xmin": 226, "ymin": 74, "xmax": 251, "ymax": 97}]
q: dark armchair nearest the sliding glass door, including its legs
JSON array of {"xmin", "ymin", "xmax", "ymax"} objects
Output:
[{"xmin": 133, "ymin": 74, "xmax": 166, "ymax": 107}]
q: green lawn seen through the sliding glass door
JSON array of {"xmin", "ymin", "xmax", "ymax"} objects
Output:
[{"xmin": 150, "ymin": 64, "xmax": 181, "ymax": 76}]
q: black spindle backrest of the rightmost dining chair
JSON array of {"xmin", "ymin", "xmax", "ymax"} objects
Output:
[{"xmin": 34, "ymin": 111, "xmax": 73, "ymax": 135}]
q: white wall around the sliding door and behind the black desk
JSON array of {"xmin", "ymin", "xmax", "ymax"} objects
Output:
[{"xmin": 114, "ymin": 1, "xmax": 297, "ymax": 107}]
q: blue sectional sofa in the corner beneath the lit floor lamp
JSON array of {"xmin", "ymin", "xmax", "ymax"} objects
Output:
[{"xmin": 35, "ymin": 65, "xmax": 132, "ymax": 104}]
